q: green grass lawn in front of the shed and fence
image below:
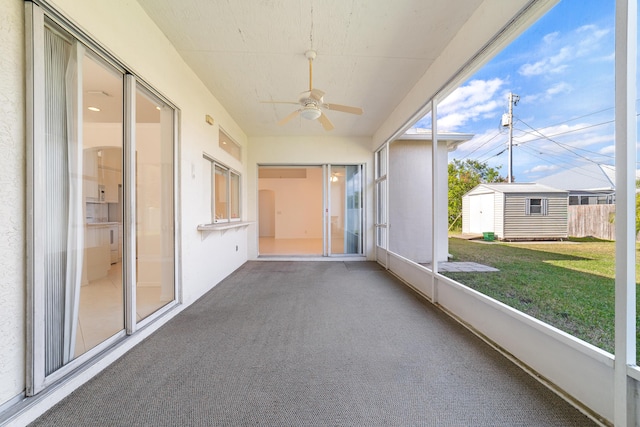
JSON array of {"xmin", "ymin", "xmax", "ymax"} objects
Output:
[{"xmin": 443, "ymin": 238, "xmax": 640, "ymax": 360}]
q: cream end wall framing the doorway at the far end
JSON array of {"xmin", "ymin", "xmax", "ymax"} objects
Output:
[{"xmin": 247, "ymin": 135, "xmax": 374, "ymax": 259}]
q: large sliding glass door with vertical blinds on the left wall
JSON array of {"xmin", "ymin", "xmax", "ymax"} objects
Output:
[{"xmin": 25, "ymin": 3, "xmax": 177, "ymax": 395}]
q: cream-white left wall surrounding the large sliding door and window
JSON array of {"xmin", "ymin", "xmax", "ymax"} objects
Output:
[{"xmin": 0, "ymin": 0, "xmax": 247, "ymax": 410}]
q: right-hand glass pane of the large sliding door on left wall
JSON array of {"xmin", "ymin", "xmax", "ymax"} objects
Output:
[{"xmin": 135, "ymin": 86, "xmax": 175, "ymax": 321}]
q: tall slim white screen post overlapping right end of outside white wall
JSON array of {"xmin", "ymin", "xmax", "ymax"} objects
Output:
[{"xmin": 431, "ymin": 97, "xmax": 440, "ymax": 303}]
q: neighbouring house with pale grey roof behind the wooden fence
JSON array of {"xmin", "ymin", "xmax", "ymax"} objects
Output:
[{"xmin": 537, "ymin": 163, "xmax": 616, "ymax": 205}]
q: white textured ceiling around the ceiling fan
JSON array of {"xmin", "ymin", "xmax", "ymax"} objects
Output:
[{"xmin": 138, "ymin": 0, "xmax": 482, "ymax": 136}]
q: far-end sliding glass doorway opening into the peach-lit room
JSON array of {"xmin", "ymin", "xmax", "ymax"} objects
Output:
[{"xmin": 258, "ymin": 164, "xmax": 363, "ymax": 256}]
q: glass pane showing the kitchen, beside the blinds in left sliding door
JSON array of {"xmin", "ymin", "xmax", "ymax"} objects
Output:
[{"xmin": 75, "ymin": 55, "xmax": 124, "ymax": 356}]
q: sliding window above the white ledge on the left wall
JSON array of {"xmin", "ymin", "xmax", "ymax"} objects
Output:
[{"xmin": 203, "ymin": 155, "xmax": 241, "ymax": 223}]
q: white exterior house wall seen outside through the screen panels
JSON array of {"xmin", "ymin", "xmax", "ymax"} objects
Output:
[{"xmin": 388, "ymin": 140, "xmax": 449, "ymax": 263}]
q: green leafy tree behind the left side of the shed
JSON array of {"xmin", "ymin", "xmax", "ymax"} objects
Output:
[{"xmin": 447, "ymin": 159, "xmax": 507, "ymax": 229}]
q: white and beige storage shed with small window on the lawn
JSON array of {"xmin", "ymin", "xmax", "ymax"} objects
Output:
[{"xmin": 462, "ymin": 183, "xmax": 568, "ymax": 240}]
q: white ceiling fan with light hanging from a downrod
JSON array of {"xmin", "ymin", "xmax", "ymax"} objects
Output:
[{"xmin": 263, "ymin": 50, "xmax": 363, "ymax": 130}]
